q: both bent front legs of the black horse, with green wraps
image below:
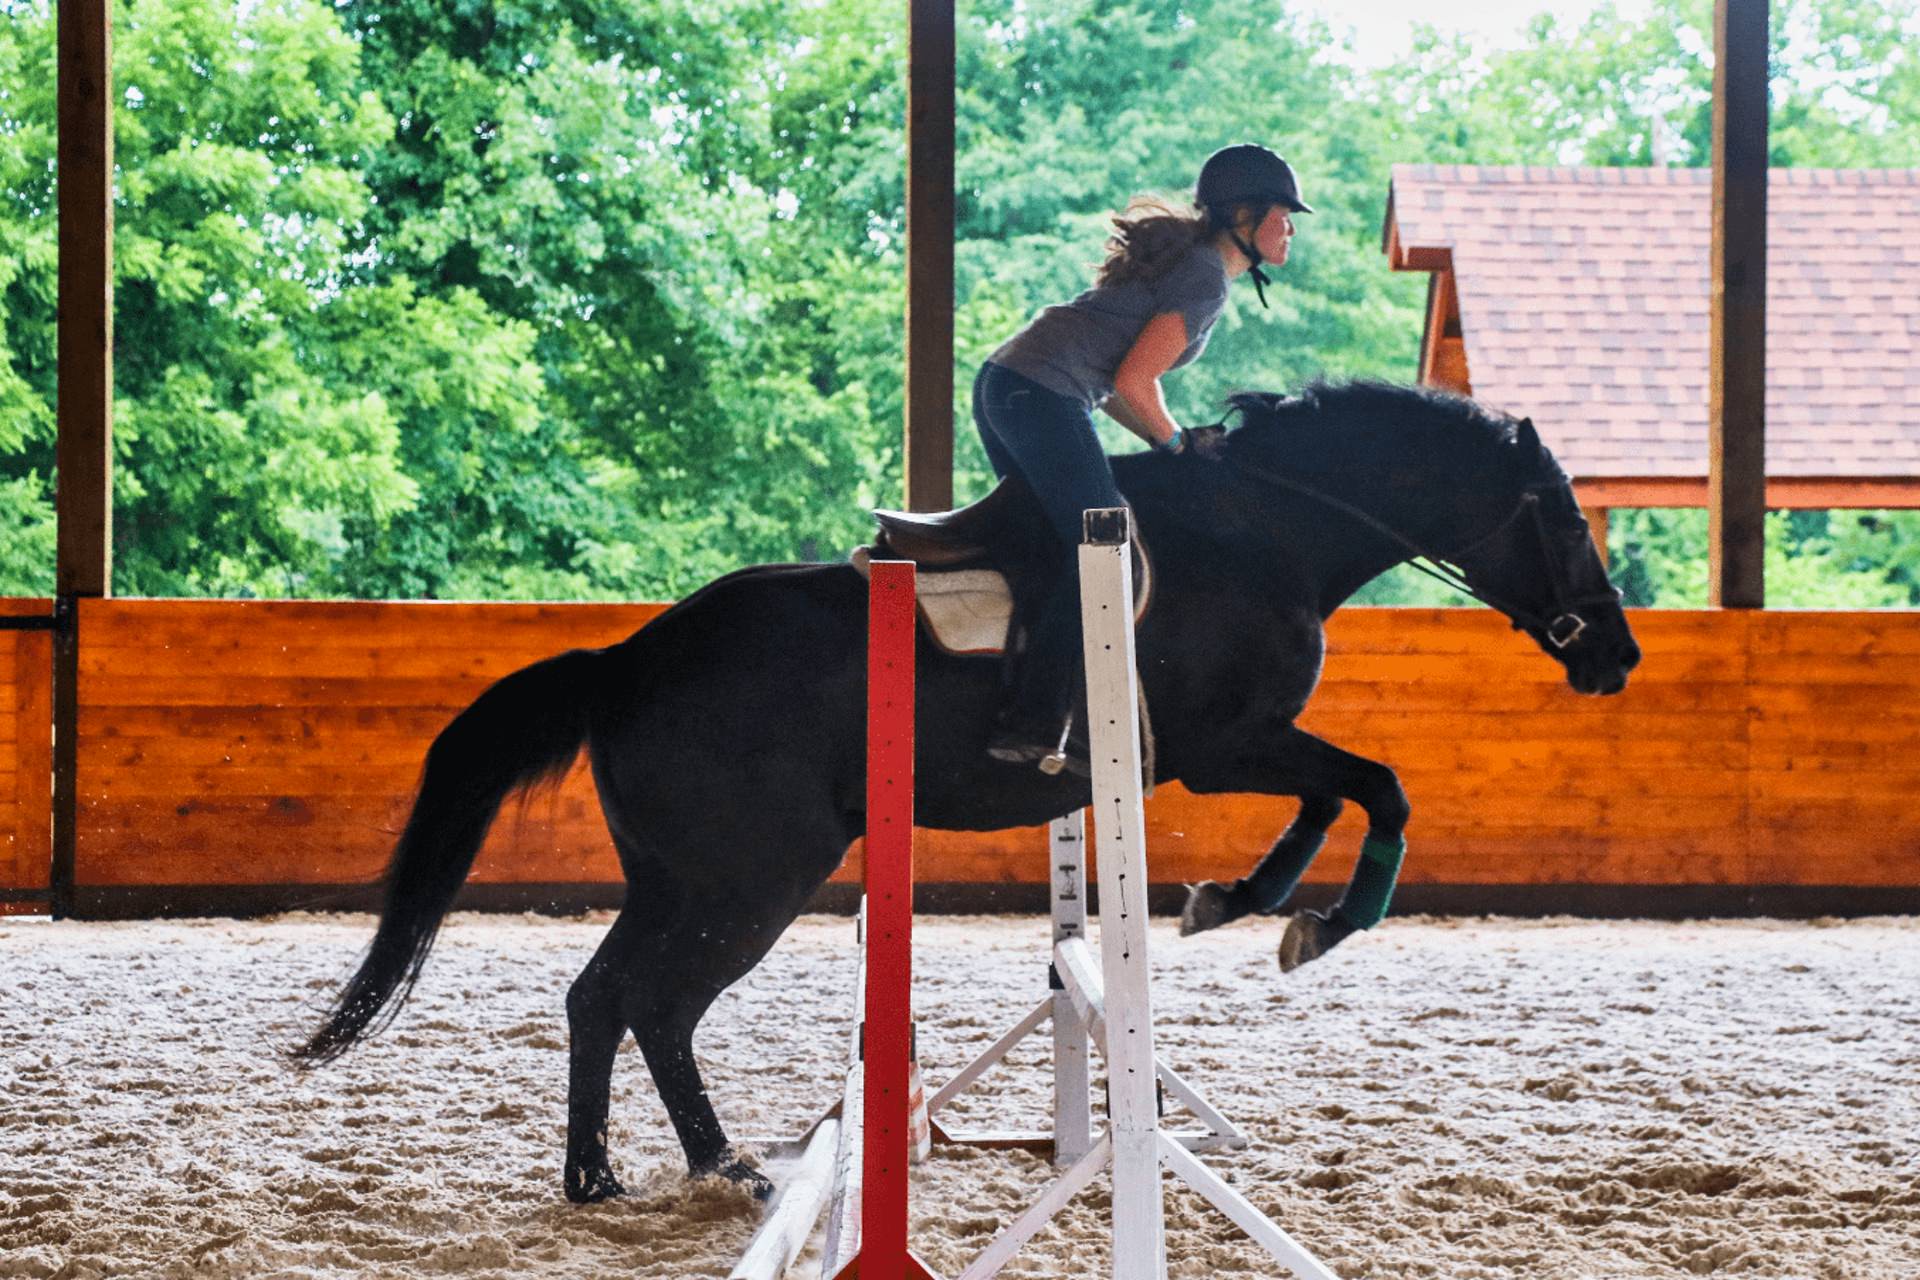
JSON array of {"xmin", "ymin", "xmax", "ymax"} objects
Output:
[{"xmin": 1181, "ymin": 725, "xmax": 1409, "ymax": 971}]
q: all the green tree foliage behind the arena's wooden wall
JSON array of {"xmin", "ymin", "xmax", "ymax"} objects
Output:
[{"xmin": 0, "ymin": 0, "xmax": 1920, "ymax": 603}]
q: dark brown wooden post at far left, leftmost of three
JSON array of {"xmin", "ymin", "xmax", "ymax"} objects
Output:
[{"xmin": 52, "ymin": 0, "xmax": 113, "ymax": 917}]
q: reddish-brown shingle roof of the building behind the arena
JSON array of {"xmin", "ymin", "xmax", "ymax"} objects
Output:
[{"xmin": 1386, "ymin": 165, "xmax": 1920, "ymax": 478}]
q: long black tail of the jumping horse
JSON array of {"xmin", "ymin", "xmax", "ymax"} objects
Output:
[{"xmin": 292, "ymin": 649, "xmax": 601, "ymax": 1065}]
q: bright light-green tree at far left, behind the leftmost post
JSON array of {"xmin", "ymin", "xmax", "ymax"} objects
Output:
[{"xmin": 0, "ymin": 0, "xmax": 591, "ymax": 595}]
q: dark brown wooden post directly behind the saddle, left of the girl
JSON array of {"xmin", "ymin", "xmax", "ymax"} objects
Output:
[{"xmin": 906, "ymin": 0, "xmax": 954, "ymax": 510}]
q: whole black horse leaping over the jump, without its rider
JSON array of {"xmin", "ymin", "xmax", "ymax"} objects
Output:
[{"xmin": 296, "ymin": 384, "xmax": 1640, "ymax": 1201}]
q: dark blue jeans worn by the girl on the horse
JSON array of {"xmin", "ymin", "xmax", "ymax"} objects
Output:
[{"xmin": 973, "ymin": 361, "xmax": 1125, "ymax": 747}]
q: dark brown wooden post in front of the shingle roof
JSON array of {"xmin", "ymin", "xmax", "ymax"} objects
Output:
[{"xmin": 1707, "ymin": 0, "xmax": 1768, "ymax": 608}]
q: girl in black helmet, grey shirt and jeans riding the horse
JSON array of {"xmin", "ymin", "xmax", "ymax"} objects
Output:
[{"xmin": 973, "ymin": 144, "xmax": 1311, "ymax": 775}]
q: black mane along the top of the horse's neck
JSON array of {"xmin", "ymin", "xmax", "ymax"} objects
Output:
[{"xmin": 1227, "ymin": 378, "xmax": 1517, "ymax": 470}]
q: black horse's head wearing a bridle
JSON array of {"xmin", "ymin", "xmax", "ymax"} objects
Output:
[{"xmin": 1450, "ymin": 418, "xmax": 1640, "ymax": 693}]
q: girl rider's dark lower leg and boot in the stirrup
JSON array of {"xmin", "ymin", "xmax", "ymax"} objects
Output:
[{"xmin": 987, "ymin": 578, "xmax": 1092, "ymax": 777}]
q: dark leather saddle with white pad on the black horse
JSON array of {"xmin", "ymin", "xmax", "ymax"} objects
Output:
[{"xmin": 851, "ymin": 478, "xmax": 1152, "ymax": 656}]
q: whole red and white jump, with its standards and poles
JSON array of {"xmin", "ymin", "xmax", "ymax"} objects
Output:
[{"xmin": 733, "ymin": 521, "xmax": 1334, "ymax": 1280}]
